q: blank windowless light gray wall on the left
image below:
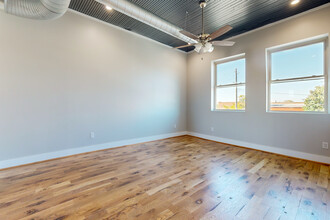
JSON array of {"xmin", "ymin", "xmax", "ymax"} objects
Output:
[{"xmin": 0, "ymin": 11, "xmax": 186, "ymax": 160}]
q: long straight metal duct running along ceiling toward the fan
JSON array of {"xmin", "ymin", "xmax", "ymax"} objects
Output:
[{"xmin": 96, "ymin": 0, "xmax": 197, "ymax": 43}]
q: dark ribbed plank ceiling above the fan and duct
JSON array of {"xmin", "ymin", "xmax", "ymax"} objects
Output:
[{"xmin": 70, "ymin": 0, "xmax": 330, "ymax": 51}]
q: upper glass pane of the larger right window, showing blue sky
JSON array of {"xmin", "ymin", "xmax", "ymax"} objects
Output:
[{"xmin": 271, "ymin": 42, "xmax": 324, "ymax": 80}]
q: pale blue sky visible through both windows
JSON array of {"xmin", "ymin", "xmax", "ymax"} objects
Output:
[{"xmin": 217, "ymin": 43, "xmax": 324, "ymax": 102}]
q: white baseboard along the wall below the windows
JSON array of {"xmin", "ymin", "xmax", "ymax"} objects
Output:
[{"xmin": 188, "ymin": 132, "xmax": 330, "ymax": 164}]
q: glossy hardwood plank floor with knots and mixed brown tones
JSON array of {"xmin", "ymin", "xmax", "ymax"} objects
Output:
[{"xmin": 0, "ymin": 136, "xmax": 330, "ymax": 220}]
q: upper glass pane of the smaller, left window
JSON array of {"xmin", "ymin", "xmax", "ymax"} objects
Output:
[{"xmin": 217, "ymin": 59, "xmax": 245, "ymax": 85}]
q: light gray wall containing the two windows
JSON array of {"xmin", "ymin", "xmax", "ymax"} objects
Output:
[{"xmin": 187, "ymin": 7, "xmax": 330, "ymax": 156}]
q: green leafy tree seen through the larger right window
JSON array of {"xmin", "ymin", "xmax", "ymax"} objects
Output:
[{"xmin": 303, "ymin": 86, "xmax": 324, "ymax": 111}]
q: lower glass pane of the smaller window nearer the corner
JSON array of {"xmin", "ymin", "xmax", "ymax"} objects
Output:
[{"xmin": 216, "ymin": 86, "xmax": 245, "ymax": 110}]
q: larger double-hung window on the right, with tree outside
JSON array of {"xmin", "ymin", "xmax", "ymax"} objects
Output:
[{"xmin": 267, "ymin": 37, "xmax": 327, "ymax": 112}]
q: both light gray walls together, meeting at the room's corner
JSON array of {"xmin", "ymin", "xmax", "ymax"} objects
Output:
[{"xmin": 0, "ymin": 4, "xmax": 330, "ymax": 160}]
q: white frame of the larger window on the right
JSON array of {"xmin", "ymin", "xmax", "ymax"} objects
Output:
[{"xmin": 266, "ymin": 34, "xmax": 329, "ymax": 114}]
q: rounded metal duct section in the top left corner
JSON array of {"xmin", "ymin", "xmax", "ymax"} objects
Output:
[{"xmin": 4, "ymin": 0, "xmax": 71, "ymax": 20}]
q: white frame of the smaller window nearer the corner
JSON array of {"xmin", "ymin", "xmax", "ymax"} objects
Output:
[{"xmin": 211, "ymin": 53, "xmax": 247, "ymax": 112}]
